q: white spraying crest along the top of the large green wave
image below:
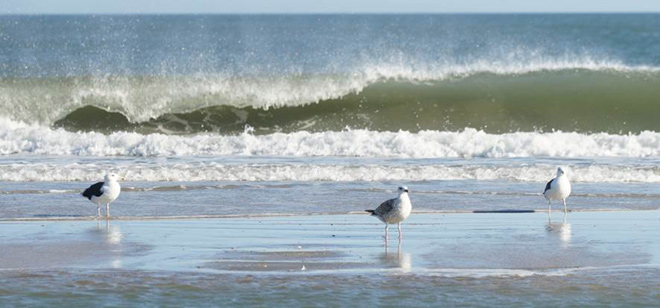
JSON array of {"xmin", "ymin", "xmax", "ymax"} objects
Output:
[{"xmin": 0, "ymin": 61, "xmax": 659, "ymax": 129}]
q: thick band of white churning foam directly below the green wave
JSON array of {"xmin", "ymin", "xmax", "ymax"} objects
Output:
[{"xmin": 0, "ymin": 119, "xmax": 660, "ymax": 158}]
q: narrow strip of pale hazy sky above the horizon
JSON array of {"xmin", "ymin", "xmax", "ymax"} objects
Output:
[{"xmin": 0, "ymin": 0, "xmax": 660, "ymax": 14}]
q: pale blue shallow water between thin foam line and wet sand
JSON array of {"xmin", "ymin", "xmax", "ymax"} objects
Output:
[{"xmin": 0, "ymin": 180, "xmax": 660, "ymax": 219}]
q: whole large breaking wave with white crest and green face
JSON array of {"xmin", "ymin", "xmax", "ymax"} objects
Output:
[{"xmin": 0, "ymin": 63, "xmax": 660, "ymax": 134}]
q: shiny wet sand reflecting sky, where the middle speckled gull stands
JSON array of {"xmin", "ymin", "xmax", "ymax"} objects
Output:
[{"xmin": 0, "ymin": 211, "xmax": 660, "ymax": 275}]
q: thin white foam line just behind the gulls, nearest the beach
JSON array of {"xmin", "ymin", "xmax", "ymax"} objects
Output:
[{"xmin": 0, "ymin": 161, "xmax": 660, "ymax": 183}]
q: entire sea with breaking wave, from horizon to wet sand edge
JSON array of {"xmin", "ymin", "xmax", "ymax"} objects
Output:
[{"xmin": 0, "ymin": 14, "xmax": 660, "ymax": 217}]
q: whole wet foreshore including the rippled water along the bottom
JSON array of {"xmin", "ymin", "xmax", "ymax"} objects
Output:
[{"xmin": 0, "ymin": 211, "xmax": 660, "ymax": 306}]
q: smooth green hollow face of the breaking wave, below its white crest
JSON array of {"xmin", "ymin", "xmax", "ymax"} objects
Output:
[{"xmin": 55, "ymin": 70, "xmax": 660, "ymax": 134}]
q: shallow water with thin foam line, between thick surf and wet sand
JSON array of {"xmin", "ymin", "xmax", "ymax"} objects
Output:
[{"xmin": 0, "ymin": 156, "xmax": 660, "ymax": 218}]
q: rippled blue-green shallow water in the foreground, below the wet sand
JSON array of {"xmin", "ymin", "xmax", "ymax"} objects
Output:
[{"xmin": 0, "ymin": 269, "xmax": 660, "ymax": 307}]
